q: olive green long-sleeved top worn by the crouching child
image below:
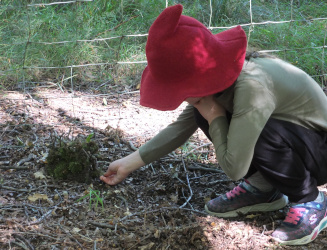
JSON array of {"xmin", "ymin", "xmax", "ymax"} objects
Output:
[{"xmin": 139, "ymin": 58, "xmax": 327, "ymax": 180}]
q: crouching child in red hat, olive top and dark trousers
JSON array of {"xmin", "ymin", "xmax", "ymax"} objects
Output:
[{"xmin": 100, "ymin": 5, "xmax": 327, "ymax": 245}]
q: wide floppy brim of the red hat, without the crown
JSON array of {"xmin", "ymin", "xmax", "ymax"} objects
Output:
[{"xmin": 140, "ymin": 26, "xmax": 247, "ymax": 111}]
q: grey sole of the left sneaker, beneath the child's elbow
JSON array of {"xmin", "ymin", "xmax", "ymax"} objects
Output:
[{"xmin": 204, "ymin": 195, "xmax": 288, "ymax": 218}]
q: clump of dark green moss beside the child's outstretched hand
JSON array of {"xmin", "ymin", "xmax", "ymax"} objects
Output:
[{"xmin": 45, "ymin": 137, "xmax": 100, "ymax": 183}]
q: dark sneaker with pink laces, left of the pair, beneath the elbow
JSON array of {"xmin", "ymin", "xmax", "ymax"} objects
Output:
[{"xmin": 205, "ymin": 181, "xmax": 288, "ymax": 218}]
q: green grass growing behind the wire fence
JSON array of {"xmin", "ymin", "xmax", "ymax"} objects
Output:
[{"xmin": 0, "ymin": 0, "xmax": 327, "ymax": 89}]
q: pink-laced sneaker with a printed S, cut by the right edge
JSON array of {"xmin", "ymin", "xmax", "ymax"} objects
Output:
[{"xmin": 272, "ymin": 190, "xmax": 327, "ymax": 245}]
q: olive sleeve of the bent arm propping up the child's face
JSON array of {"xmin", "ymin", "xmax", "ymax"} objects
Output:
[{"xmin": 209, "ymin": 80, "xmax": 275, "ymax": 180}]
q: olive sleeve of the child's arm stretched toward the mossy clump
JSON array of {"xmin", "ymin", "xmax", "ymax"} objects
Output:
[{"xmin": 139, "ymin": 105, "xmax": 198, "ymax": 164}]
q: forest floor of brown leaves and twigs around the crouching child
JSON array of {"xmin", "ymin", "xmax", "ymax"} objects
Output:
[{"xmin": 0, "ymin": 85, "xmax": 327, "ymax": 250}]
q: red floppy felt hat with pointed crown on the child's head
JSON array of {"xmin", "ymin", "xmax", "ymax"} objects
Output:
[{"xmin": 140, "ymin": 4, "xmax": 247, "ymax": 111}]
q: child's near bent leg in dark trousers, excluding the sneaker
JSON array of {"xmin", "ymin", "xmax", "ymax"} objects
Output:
[{"xmin": 252, "ymin": 119, "xmax": 327, "ymax": 203}]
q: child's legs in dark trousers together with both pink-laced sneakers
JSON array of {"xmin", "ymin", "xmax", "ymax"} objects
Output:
[{"xmin": 195, "ymin": 108, "xmax": 327, "ymax": 245}]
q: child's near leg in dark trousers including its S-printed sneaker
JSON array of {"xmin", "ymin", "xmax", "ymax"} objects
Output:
[{"xmin": 252, "ymin": 119, "xmax": 327, "ymax": 245}]
